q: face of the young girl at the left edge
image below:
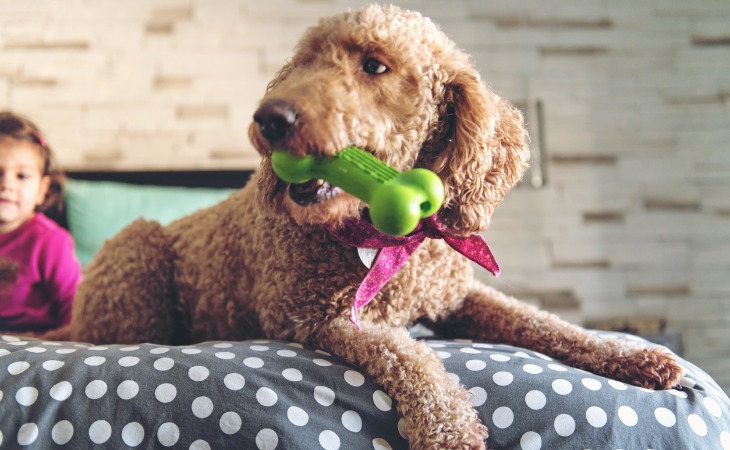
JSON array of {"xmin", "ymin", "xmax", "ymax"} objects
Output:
[{"xmin": 0, "ymin": 138, "xmax": 51, "ymax": 233}]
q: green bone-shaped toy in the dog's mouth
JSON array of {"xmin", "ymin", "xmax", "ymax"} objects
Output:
[{"xmin": 271, "ymin": 147, "xmax": 444, "ymax": 236}]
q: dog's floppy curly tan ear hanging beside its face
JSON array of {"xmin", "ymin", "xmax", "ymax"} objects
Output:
[{"xmin": 421, "ymin": 63, "xmax": 530, "ymax": 239}]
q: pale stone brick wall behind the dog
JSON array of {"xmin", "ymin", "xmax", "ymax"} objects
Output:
[{"xmin": 0, "ymin": 0, "xmax": 730, "ymax": 389}]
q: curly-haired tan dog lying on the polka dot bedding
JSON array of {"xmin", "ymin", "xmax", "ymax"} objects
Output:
[{"xmin": 39, "ymin": 6, "xmax": 681, "ymax": 448}]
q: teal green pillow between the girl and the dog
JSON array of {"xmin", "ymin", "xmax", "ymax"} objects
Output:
[{"xmin": 63, "ymin": 179, "xmax": 236, "ymax": 266}]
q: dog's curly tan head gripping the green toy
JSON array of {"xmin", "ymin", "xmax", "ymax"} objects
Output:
[{"xmin": 249, "ymin": 6, "xmax": 529, "ymax": 235}]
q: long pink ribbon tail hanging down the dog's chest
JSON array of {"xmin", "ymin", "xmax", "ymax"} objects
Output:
[{"xmin": 350, "ymin": 241, "xmax": 423, "ymax": 330}]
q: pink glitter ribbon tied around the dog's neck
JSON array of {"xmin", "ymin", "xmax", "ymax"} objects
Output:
[{"xmin": 327, "ymin": 214, "xmax": 499, "ymax": 329}]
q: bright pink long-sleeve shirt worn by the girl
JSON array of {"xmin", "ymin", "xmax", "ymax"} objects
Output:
[{"xmin": 0, "ymin": 213, "xmax": 81, "ymax": 331}]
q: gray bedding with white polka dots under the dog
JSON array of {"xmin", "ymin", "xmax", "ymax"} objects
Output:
[{"xmin": 0, "ymin": 336, "xmax": 730, "ymax": 450}]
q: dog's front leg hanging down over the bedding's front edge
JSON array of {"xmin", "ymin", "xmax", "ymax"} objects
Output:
[{"xmin": 317, "ymin": 319, "xmax": 487, "ymax": 449}]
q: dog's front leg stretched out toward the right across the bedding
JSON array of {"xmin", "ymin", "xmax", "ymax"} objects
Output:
[{"xmin": 435, "ymin": 282, "xmax": 683, "ymax": 389}]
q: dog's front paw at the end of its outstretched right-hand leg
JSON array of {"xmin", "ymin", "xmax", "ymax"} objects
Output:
[{"xmin": 604, "ymin": 347, "xmax": 684, "ymax": 389}]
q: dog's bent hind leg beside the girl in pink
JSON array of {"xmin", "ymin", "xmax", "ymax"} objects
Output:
[{"xmin": 68, "ymin": 219, "xmax": 178, "ymax": 344}]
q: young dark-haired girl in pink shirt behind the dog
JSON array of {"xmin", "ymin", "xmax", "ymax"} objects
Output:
[{"xmin": 0, "ymin": 111, "xmax": 81, "ymax": 332}]
